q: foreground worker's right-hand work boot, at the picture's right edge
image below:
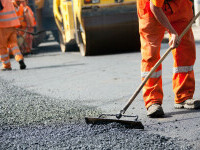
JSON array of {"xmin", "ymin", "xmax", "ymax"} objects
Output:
[{"xmin": 174, "ymin": 99, "xmax": 200, "ymax": 109}]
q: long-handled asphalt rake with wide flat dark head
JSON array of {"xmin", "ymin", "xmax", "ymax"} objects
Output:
[{"xmin": 85, "ymin": 12, "xmax": 200, "ymax": 129}]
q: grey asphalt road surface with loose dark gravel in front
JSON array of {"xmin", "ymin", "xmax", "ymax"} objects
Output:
[{"xmin": 0, "ymin": 31, "xmax": 200, "ymax": 149}]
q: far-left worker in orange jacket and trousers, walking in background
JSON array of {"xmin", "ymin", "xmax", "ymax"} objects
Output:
[{"xmin": 0, "ymin": 0, "xmax": 26, "ymax": 71}]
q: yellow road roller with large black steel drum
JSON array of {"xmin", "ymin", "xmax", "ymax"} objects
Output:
[{"xmin": 53, "ymin": 0, "xmax": 140, "ymax": 56}]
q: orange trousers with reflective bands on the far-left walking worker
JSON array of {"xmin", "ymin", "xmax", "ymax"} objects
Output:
[{"xmin": 0, "ymin": 27, "xmax": 23, "ymax": 68}]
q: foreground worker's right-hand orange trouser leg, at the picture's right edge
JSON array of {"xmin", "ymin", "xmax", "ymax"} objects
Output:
[{"xmin": 172, "ymin": 22, "xmax": 196, "ymax": 103}]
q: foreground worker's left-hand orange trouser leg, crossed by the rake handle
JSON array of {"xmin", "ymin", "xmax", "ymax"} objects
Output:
[{"xmin": 139, "ymin": 17, "xmax": 165, "ymax": 108}]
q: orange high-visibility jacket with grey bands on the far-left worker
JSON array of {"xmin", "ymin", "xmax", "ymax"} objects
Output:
[{"xmin": 0, "ymin": 0, "xmax": 20, "ymax": 28}]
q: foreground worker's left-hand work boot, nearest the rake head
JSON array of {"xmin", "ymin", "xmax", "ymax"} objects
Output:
[{"xmin": 147, "ymin": 104, "xmax": 164, "ymax": 118}]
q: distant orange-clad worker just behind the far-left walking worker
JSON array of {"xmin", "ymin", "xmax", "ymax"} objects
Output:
[{"xmin": 14, "ymin": 0, "xmax": 36, "ymax": 54}]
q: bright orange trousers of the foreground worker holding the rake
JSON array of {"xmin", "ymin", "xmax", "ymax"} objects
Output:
[{"xmin": 137, "ymin": 0, "xmax": 196, "ymax": 108}]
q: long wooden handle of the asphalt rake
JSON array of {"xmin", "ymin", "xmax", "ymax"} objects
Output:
[{"xmin": 120, "ymin": 11, "xmax": 200, "ymax": 114}]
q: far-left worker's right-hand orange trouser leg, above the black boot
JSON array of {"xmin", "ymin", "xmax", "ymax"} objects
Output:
[{"xmin": 8, "ymin": 28, "xmax": 24, "ymax": 62}]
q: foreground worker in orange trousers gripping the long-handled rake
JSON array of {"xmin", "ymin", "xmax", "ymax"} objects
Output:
[{"xmin": 137, "ymin": 0, "xmax": 200, "ymax": 117}]
